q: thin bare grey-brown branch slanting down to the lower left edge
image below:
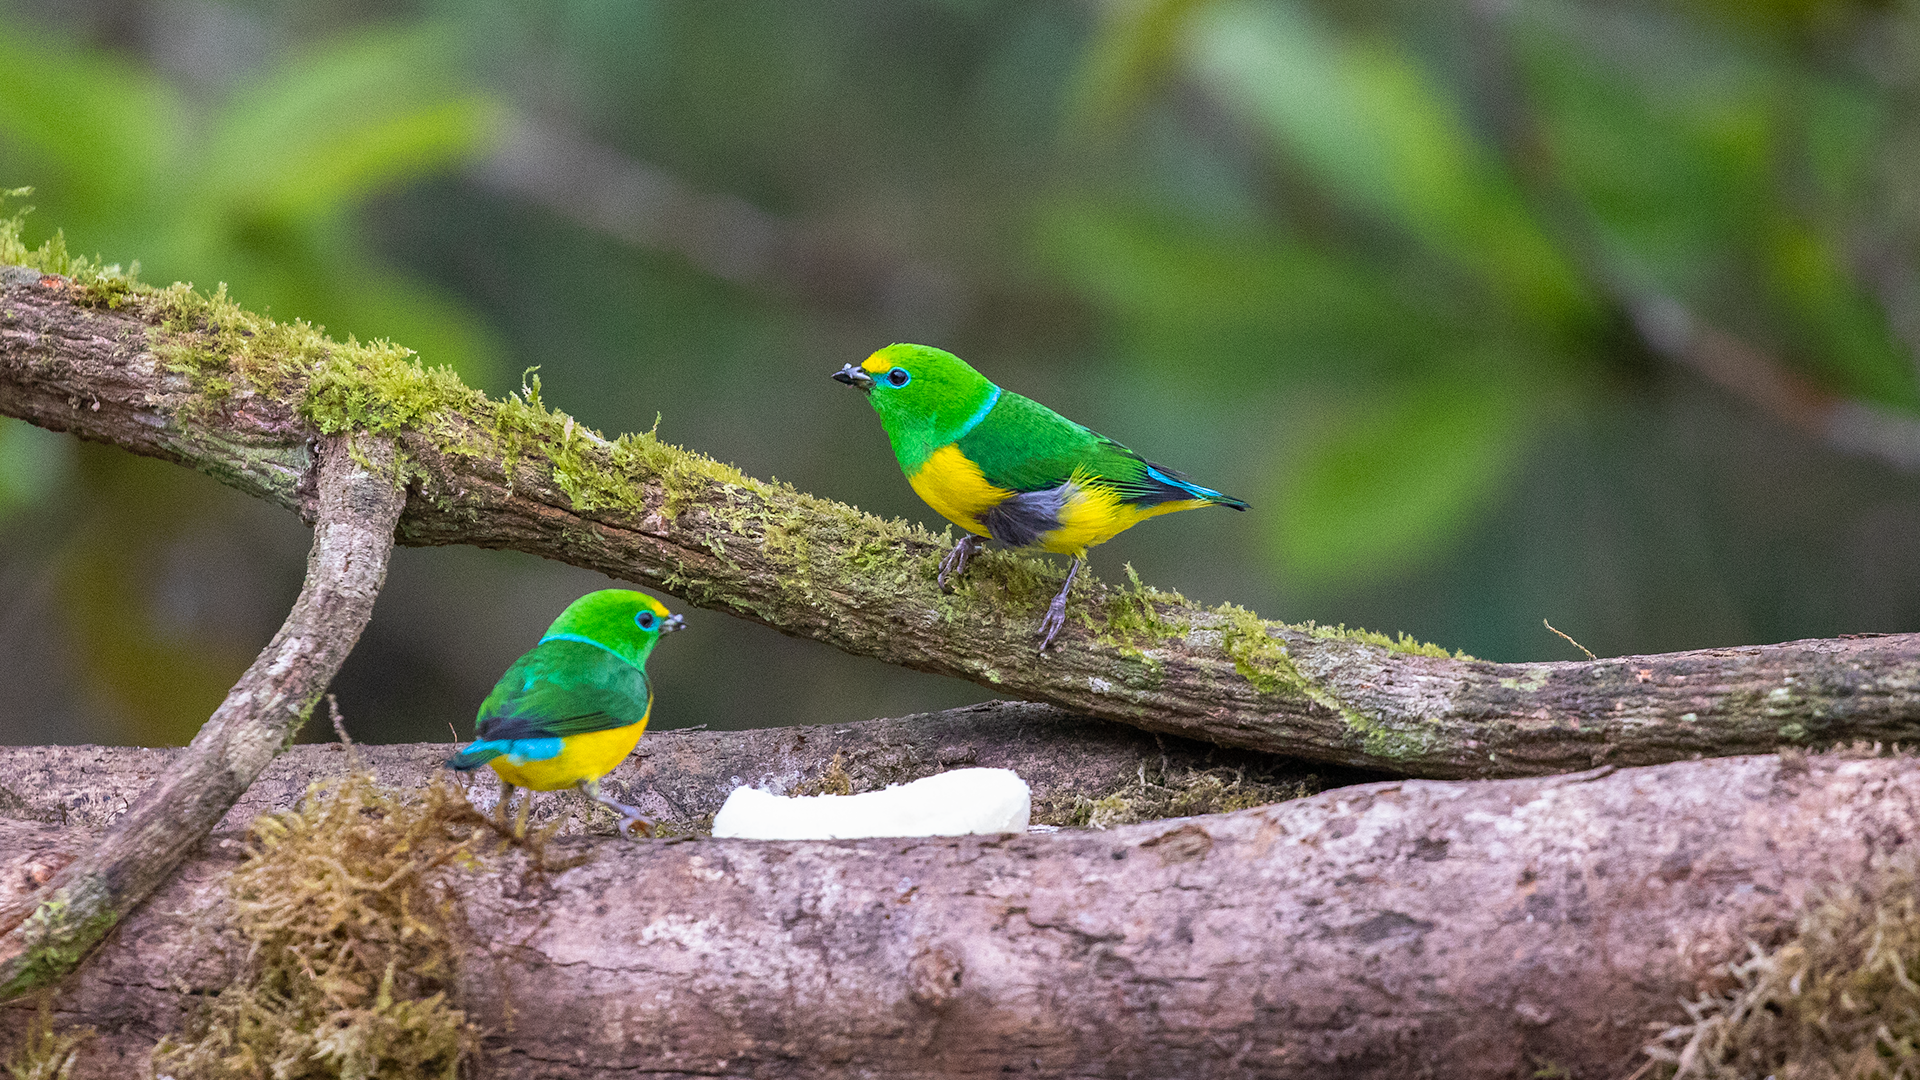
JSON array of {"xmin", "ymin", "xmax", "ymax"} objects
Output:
[{"xmin": 0, "ymin": 424, "xmax": 405, "ymax": 1001}]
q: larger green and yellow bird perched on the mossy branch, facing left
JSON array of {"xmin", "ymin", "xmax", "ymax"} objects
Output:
[{"xmin": 833, "ymin": 344, "xmax": 1246, "ymax": 650}]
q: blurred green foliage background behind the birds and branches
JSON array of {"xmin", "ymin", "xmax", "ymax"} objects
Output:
[{"xmin": 0, "ymin": 0, "xmax": 1920, "ymax": 744}]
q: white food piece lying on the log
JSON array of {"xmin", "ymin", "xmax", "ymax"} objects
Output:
[{"xmin": 714, "ymin": 769, "xmax": 1033, "ymax": 840}]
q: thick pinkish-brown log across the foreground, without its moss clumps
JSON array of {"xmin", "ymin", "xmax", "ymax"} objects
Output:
[{"xmin": 0, "ymin": 753, "xmax": 1920, "ymax": 1078}]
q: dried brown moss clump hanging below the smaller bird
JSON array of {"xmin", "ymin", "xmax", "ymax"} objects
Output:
[{"xmin": 154, "ymin": 773, "xmax": 493, "ymax": 1080}]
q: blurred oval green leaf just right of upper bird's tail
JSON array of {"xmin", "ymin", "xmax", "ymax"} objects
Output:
[{"xmin": 1273, "ymin": 375, "xmax": 1538, "ymax": 590}]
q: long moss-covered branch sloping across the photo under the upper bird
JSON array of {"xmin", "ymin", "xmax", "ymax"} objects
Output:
[{"xmin": 0, "ymin": 267, "xmax": 1920, "ymax": 778}]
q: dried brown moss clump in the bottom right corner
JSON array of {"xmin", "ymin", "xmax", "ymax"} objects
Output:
[{"xmin": 1647, "ymin": 863, "xmax": 1920, "ymax": 1080}]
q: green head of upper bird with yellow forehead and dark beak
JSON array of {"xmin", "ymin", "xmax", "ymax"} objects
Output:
[{"xmin": 833, "ymin": 344, "xmax": 1000, "ymax": 466}]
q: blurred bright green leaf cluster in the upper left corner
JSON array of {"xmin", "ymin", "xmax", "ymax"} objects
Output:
[{"xmin": 0, "ymin": 23, "xmax": 507, "ymax": 384}]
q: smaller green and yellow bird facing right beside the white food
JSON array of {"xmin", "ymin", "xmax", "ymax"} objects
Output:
[{"xmin": 447, "ymin": 588, "xmax": 682, "ymax": 836}]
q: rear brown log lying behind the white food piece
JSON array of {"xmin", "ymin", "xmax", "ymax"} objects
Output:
[{"xmin": 0, "ymin": 701, "xmax": 1380, "ymax": 836}]
